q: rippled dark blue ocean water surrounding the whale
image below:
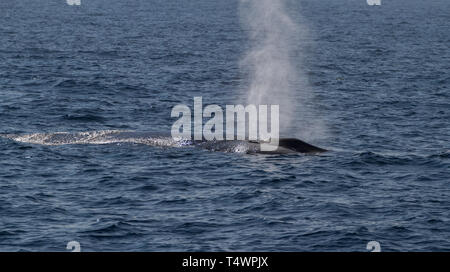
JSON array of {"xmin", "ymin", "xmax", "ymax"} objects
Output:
[{"xmin": 0, "ymin": 0, "xmax": 450, "ymax": 251}]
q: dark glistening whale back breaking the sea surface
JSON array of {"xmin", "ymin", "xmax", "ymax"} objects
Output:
[{"xmin": 0, "ymin": 130, "xmax": 326, "ymax": 154}]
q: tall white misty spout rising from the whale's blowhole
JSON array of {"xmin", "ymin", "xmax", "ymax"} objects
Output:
[{"xmin": 240, "ymin": 0, "xmax": 324, "ymax": 139}]
